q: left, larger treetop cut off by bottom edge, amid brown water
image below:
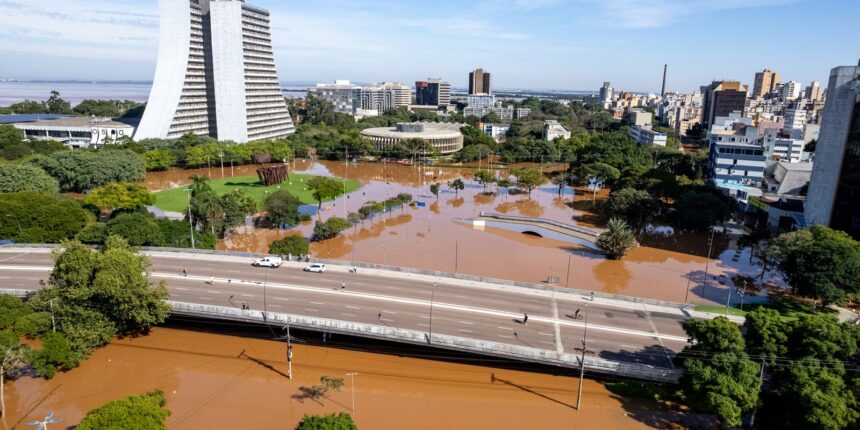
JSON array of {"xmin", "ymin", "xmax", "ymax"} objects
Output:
[{"xmin": 75, "ymin": 390, "xmax": 170, "ymax": 430}]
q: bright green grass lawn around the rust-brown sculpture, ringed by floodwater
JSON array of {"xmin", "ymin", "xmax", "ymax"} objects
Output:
[{"xmin": 155, "ymin": 174, "xmax": 361, "ymax": 212}]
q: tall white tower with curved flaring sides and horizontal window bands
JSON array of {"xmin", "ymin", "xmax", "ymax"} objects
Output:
[{"xmin": 134, "ymin": 0, "xmax": 295, "ymax": 143}]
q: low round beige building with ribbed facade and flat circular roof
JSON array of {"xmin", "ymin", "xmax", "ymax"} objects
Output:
[{"xmin": 361, "ymin": 122, "xmax": 463, "ymax": 155}]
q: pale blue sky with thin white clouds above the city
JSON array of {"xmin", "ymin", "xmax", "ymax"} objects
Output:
[{"xmin": 0, "ymin": 0, "xmax": 860, "ymax": 92}]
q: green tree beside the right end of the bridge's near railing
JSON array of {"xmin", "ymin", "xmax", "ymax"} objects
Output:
[{"xmin": 679, "ymin": 317, "xmax": 761, "ymax": 426}]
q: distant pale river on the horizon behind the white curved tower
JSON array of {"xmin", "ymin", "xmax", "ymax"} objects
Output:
[{"xmin": 0, "ymin": 82, "xmax": 307, "ymax": 106}]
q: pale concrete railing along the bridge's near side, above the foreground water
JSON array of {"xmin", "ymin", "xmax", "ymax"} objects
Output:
[{"xmin": 169, "ymin": 302, "xmax": 681, "ymax": 382}]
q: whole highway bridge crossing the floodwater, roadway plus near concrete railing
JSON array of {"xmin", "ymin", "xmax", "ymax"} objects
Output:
[{"xmin": 0, "ymin": 246, "xmax": 688, "ymax": 381}]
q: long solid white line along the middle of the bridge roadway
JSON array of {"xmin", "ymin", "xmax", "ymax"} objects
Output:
[{"xmin": 153, "ymin": 272, "xmax": 688, "ymax": 343}]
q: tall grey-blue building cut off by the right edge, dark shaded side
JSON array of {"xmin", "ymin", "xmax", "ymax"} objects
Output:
[{"xmin": 805, "ymin": 63, "xmax": 860, "ymax": 239}]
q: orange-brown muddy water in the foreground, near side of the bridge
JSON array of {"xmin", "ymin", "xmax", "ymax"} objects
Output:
[{"xmin": 6, "ymin": 328, "xmax": 672, "ymax": 430}]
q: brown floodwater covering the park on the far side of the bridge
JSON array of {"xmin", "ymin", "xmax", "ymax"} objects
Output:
[{"xmin": 147, "ymin": 161, "xmax": 751, "ymax": 303}]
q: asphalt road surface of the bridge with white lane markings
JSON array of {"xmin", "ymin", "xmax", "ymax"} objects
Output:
[{"xmin": 0, "ymin": 248, "xmax": 687, "ymax": 368}]
